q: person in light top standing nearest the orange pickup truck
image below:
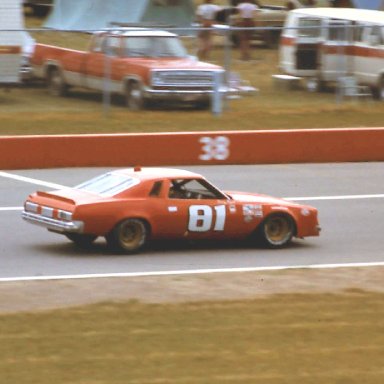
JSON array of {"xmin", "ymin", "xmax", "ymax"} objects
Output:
[{"xmin": 196, "ymin": 0, "xmax": 221, "ymax": 59}]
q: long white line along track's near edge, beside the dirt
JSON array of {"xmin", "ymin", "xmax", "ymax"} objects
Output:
[{"xmin": 0, "ymin": 261, "xmax": 384, "ymax": 283}]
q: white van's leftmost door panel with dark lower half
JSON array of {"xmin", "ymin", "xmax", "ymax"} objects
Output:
[{"xmin": 295, "ymin": 17, "xmax": 322, "ymax": 77}]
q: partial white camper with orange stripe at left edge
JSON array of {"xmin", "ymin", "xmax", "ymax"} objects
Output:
[{"xmin": 0, "ymin": 0, "xmax": 25, "ymax": 86}]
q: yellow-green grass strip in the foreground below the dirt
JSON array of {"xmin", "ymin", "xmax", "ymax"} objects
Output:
[{"xmin": 0, "ymin": 291, "xmax": 384, "ymax": 384}]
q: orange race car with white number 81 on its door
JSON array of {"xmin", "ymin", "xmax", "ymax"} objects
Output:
[{"xmin": 22, "ymin": 167, "xmax": 320, "ymax": 254}]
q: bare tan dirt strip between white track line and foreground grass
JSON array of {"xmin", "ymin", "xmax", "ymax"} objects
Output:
[{"xmin": 0, "ymin": 267, "xmax": 384, "ymax": 314}]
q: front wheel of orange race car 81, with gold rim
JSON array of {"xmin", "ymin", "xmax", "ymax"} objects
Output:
[{"xmin": 258, "ymin": 213, "xmax": 296, "ymax": 248}]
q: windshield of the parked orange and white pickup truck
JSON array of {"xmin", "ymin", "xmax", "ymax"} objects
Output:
[{"xmin": 123, "ymin": 36, "xmax": 187, "ymax": 57}]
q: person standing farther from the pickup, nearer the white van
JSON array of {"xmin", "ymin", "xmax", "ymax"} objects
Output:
[{"xmin": 236, "ymin": 0, "xmax": 259, "ymax": 60}]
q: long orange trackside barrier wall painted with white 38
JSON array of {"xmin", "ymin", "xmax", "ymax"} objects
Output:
[{"xmin": 0, "ymin": 128, "xmax": 384, "ymax": 169}]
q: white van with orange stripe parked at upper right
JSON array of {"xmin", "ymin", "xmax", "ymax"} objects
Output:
[{"xmin": 279, "ymin": 8, "xmax": 384, "ymax": 100}]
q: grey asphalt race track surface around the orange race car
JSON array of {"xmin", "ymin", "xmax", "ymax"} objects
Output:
[{"xmin": 0, "ymin": 163, "xmax": 384, "ymax": 278}]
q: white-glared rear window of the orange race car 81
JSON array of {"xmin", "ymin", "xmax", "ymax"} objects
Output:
[{"xmin": 75, "ymin": 172, "xmax": 139, "ymax": 197}]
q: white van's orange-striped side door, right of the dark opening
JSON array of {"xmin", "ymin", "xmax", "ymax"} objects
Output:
[{"xmin": 320, "ymin": 20, "xmax": 353, "ymax": 81}]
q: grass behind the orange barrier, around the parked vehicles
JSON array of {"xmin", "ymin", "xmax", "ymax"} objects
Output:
[{"xmin": 0, "ymin": 13, "xmax": 384, "ymax": 135}]
